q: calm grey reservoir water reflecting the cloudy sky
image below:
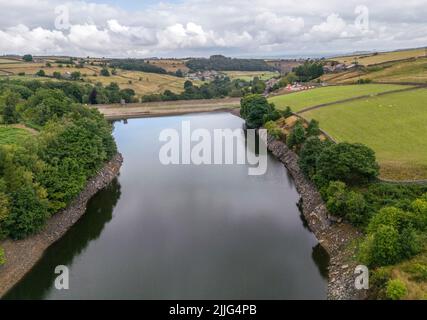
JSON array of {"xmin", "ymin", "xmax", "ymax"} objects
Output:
[{"xmin": 6, "ymin": 113, "xmax": 328, "ymax": 299}]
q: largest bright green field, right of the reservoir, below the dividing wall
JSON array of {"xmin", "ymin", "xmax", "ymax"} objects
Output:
[{"xmin": 302, "ymin": 89, "xmax": 427, "ymax": 179}]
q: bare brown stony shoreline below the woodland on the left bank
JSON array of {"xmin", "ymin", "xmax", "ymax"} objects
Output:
[{"xmin": 0, "ymin": 153, "xmax": 123, "ymax": 298}]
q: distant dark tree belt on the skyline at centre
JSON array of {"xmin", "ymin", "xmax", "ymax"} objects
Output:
[{"xmin": 186, "ymin": 55, "xmax": 274, "ymax": 71}]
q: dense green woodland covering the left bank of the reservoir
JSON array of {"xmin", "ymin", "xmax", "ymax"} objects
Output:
[{"xmin": 0, "ymin": 81, "xmax": 117, "ymax": 239}]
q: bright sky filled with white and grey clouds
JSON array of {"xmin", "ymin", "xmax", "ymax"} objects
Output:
[{"xmin": 0, "ymin": 0, "xmax": 427, "ymax": 57}]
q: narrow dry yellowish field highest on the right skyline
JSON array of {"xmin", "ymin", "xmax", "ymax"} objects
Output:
[{"xmin": 331, "ymin": 48, "xmax": 427, "ymax": 66}]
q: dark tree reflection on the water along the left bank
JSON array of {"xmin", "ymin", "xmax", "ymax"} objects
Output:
[{"xmin": 3, "ymin": 178, "xmax": 121, "ymax": 300}]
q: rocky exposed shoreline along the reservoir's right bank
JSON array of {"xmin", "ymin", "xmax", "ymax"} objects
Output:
[{"xmin": 231, "ymin": 110, "xmax": 367, "ymax": 300}]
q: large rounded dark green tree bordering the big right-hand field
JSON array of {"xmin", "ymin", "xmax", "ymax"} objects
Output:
[{"xmin": 316, "ymin": 142, "xmax": 379, "ymax": 184}]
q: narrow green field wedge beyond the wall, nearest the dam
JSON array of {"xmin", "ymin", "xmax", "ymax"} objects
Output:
[{"xmin": 268, "ymin": 84, "xmax": 412, "ymax": 112}]
